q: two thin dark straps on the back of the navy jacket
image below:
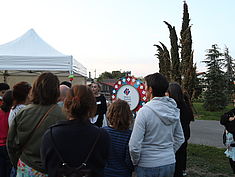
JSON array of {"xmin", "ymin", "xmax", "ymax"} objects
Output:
[{"xmin": 50, "ymin": 127, "xmax": 101, "ymax": 168}]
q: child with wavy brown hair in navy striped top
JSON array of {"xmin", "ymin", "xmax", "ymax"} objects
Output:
[{"xmin": 104, "ymin": 99, "xmax": 133, "ymax": 177}]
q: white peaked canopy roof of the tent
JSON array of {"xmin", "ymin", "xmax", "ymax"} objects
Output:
[{"xmin": 0, "ymin": 29, "xmax": 87, "ymax": 77}]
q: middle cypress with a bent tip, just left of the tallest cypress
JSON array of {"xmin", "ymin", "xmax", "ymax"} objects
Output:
[{"xmin": 164, "ymin": 21, "xmax": 181, "ymax": 84}]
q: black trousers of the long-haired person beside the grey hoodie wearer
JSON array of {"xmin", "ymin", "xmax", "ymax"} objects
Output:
[{"xmin": 174, "ymin": 141, "xmax": 188, "ymax": 177}]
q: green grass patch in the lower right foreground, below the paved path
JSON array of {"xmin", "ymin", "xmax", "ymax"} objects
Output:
[{"xmin": 187, "ymin": 144, "xmax": 234, "ymax": 177}]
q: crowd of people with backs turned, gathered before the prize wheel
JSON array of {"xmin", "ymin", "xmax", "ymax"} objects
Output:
[{"xmin": 0, "ymin": 72, "xmax": 198, "ymax": 177}]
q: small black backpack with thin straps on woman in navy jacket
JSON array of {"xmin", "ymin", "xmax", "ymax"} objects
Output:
[{"xmin": 50, "ymin": 127, "xmax": 100, "ymax": 177}]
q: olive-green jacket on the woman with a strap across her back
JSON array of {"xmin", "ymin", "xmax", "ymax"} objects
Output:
[{"xmin": 7, "ymin": 104, "xmax": 66, "ymax": 173}]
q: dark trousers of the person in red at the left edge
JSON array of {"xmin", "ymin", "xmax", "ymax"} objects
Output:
[{"xmin": 0, "ymin": 146, "xmax": 12, "ymax": 177}]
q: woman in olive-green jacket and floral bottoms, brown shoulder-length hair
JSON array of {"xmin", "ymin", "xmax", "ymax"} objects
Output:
[{"xmin": 7, "ymin": 72, "xmax": 65, "ymax": 177}]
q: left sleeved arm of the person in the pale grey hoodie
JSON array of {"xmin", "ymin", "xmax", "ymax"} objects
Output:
[{"xmin": 129, "ymin": 110, "xmax": 146, "ymax": 165}]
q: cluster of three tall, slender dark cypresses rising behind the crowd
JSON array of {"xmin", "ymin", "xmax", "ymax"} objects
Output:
[{"xmin": 154, "ymin": 1, "xmax": 196, "ymax": 99}]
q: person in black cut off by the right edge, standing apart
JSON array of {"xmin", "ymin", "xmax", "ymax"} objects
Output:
[{"xmin": 220, "ymin": 109, "xmax": 235, "ymax": 174}]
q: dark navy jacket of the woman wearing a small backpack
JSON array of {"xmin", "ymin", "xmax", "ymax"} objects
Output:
[{"xmin": 41, "ymin": 119, "xmax": 110, "ymax": 177}]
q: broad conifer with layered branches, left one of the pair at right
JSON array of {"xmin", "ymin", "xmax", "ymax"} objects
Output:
[{"xmin": 203, "ymin": 44, "xmax": 227, "ymax": 111}]
